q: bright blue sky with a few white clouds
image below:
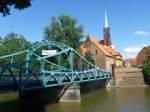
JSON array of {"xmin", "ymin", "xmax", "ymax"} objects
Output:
[{"xmin": 0, "ymin": 0, "xmax": 150, "ymax": 58}]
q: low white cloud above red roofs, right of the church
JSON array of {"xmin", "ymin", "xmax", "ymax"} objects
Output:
[{"xmin": 122, "ymin": 44, "xmax": 147, "ymax": 59}]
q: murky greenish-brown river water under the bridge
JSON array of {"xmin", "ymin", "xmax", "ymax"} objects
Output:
[{"xmin": 0, "ymin": 87, "xmax": 150, "ymax": 112}]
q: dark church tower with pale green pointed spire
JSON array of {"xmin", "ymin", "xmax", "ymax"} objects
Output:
[{"xmin": 103, "ymin": 11, "xmax": 112, "ymax": 47}]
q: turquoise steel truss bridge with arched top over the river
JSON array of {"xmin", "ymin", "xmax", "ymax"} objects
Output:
[{"xmin": 0, "ymin": 41, "xmax": 112, "ymax": 90}]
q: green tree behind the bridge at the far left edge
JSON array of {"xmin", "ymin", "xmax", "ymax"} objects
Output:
[{"xmin": 0, "ymin": 32, "xmax": 31, "ymax": 63}]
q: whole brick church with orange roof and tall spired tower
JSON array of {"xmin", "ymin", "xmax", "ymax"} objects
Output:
[{"xmin": 80, "ymin": 12, "xmax": 123, "ymax": 70}]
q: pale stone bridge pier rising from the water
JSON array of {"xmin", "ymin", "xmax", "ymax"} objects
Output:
[{"xmin": 59, "ymin": 85, "xmax": 80, "ymax": 102}]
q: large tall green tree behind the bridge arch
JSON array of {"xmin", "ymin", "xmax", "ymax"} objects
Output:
[{"xmin": 44, "ymin": 15, "xmax": 83, "ymax": 49}]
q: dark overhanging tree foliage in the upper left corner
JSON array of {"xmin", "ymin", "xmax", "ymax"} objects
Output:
[{"xmin": 0, "ymin": 0, "xmax": 32, "ymax": 16}]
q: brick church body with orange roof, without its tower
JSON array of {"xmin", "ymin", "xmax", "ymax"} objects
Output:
[{"xmin": 81, "ymin": 37, "xmax": 123, "ymax": 70}]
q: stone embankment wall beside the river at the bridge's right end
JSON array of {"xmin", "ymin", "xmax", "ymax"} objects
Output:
[{"xmin": 114, "ymin": 68, "xmax": 145, "ymax": 87}]
